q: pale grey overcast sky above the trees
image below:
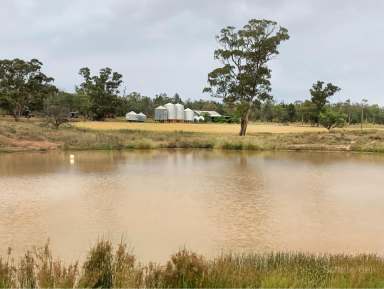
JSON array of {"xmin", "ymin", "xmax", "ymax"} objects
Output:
[{"xmin": 0, "ymin": 0, "xmax": 384, "ymax": 105}]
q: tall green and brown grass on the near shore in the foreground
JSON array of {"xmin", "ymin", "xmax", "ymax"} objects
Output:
[{"xmin": 0, "ymin": 241, "xmax": 384, "ymax": 288}]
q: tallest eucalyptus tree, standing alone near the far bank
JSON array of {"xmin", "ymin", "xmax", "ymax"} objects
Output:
[{"xmin": 204, "ymin": 19, "xmax": 289, "ymax": 136}]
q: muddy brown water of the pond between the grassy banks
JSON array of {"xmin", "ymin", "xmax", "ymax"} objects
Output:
[{"xmin": 0, "ymin": 150, "xmax": 384, "ymax": 261}]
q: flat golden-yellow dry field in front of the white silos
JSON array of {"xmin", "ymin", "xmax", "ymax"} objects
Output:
[{"xmin": 74, "ymin": 121, "xmax": 326, "ymax": 135}]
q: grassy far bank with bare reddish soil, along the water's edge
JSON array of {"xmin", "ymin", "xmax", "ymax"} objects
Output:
[{"xmin": 0, "ymin": 119, "xmax": 384, "ymax": 152}]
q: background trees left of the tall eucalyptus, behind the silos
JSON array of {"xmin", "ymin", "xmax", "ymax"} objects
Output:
[{"xmin": 0, "ymin": 59, "xmax": 225, "ymax": 125}]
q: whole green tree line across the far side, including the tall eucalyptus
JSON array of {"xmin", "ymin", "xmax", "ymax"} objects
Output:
[{"xmin": 0, "ymin": 19, "xmax": 384, "ymax": 135}]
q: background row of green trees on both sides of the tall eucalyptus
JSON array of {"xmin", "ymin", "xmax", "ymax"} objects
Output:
[{"xmin": 0, "ymin": 59, "xmax": 384, "ymax": 128}]
